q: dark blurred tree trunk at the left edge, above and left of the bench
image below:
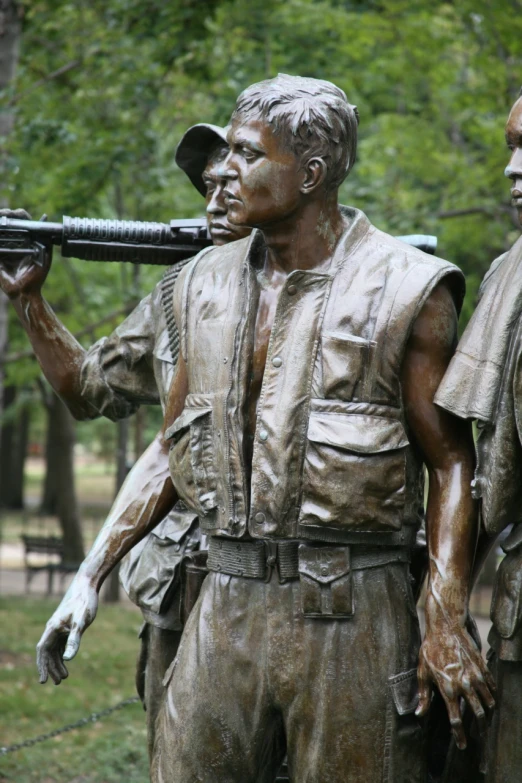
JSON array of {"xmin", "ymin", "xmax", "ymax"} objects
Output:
[{"xmin": 0, "ymin": 386, "xmax": 29, "ymax": 510}]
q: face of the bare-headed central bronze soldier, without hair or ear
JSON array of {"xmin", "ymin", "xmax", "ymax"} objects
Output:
[{"xmin": 223, "ymin": 118, "xmax": 304, "ymax": 228}]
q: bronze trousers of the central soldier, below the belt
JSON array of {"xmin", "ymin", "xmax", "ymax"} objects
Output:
[{"xmin": 151, "ymin": 563, "xmax": 425, "ymax": 783}]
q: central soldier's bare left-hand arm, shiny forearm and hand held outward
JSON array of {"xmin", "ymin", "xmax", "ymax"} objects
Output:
[{"xmin": 37, "ymin": 357, "xmax": 187, "ymax": 685}]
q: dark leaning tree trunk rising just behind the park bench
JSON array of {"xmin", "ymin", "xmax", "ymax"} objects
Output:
[{"xmin": 43, "ymin": 392, "xmax": 85, "ymax": 564}]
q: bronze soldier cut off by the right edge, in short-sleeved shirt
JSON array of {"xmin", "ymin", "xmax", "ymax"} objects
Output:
[{"xmin": 435, "ymin": 89, "xmax": 522, "ymax": 783}]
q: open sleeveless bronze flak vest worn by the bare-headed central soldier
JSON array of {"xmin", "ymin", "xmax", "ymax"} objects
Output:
[{"xmin": 166, "ymin": 207, "xmax": 464, "ymax": 545}]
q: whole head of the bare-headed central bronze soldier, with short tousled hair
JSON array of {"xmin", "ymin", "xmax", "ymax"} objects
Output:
[{"xmin": 219, "ymin": 74, "xmax": 358, "ymax": 227}]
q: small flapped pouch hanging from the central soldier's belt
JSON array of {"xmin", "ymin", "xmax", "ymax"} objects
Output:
[{"xmin": 299, "ymin": 544, "xmax": 354, "ymax": 619}]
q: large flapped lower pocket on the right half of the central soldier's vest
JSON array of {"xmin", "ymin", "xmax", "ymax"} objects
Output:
[{"xmin": 299, "ymin": 400, "xmax": 408, "ymax": 532}]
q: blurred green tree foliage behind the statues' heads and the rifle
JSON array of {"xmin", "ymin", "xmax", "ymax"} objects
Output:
[{"xmin": 4, "ymin": 0, "xmax": 522, "ymax": 382}]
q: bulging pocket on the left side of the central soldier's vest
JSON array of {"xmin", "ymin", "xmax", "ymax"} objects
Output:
[{"xmin": 165, "ymin": 406, "xmax": 217, "ymax": 516}]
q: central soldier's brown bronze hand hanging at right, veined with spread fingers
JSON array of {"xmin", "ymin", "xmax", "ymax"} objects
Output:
[{"xmin": 417, "ymin": 594, "xmax": 495, "ymax": 750}]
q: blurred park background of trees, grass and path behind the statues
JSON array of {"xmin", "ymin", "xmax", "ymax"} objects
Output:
[{"xmin": 0, "ymin": 0, "xmax": 522, "ymax": 783}]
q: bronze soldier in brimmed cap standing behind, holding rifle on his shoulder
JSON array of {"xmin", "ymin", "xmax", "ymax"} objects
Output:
[{"xmin": 0, "ymin": 124, "xmax": 250, "ymax": 752}]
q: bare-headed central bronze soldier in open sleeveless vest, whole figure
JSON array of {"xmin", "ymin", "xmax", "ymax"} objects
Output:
[{"xmin": 38, "ymin": 75, "xmax": 493, "ymax": 783}]
